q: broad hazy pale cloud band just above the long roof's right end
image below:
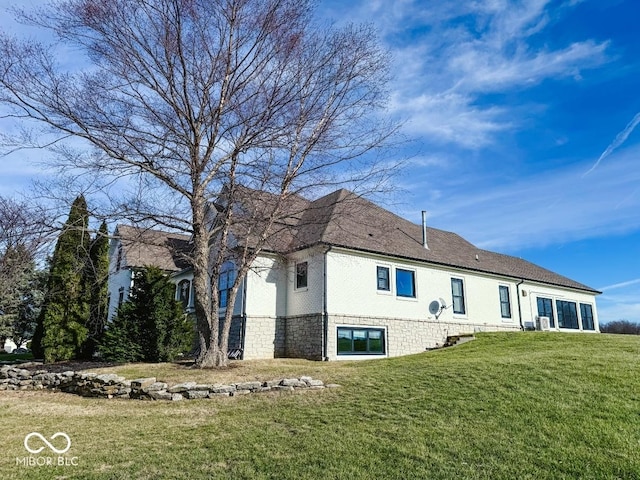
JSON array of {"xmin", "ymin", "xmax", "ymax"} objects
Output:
[{"xmin": 412, "ymin": 145, "xmax": 640, "ymax": 251}]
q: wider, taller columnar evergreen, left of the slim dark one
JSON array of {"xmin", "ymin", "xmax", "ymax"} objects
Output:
[{"xmin": 33, "ymin": 195, "xmax": 90, "ymax": 363}]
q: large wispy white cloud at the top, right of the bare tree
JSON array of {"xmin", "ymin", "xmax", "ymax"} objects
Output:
[{"xmin": 322, "ymin": 0, "xmax": 609, "ymax": 150}]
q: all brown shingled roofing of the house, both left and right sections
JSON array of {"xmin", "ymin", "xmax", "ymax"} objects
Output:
[{"xmin": 117, "ymin": 189, "xmax": 600, "ymax": 293}]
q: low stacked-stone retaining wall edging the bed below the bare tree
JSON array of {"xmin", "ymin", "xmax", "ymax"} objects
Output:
[{"xmin": 0, "ymin": 366, "xmax": 339, "ymax": 401}]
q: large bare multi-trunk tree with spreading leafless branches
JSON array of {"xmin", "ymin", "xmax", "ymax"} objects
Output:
[{"xmin": 0, "ymin": 0, "xmax": 397, "ymax": 367}]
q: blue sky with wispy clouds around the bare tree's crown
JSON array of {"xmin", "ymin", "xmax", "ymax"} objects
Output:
[{"xmin": 0, "ymin": 0, "xmax": 640, "ymax": 322}]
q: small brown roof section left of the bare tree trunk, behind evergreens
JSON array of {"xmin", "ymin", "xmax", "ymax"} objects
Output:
[{"xmin": 115, "ymin": 225, "xmax": 191, "ymax": 272}]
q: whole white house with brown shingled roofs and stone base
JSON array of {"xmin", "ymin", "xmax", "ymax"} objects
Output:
[{"xmin": 109, "ymin": 190, "xmax": 600, "ymax": 360}]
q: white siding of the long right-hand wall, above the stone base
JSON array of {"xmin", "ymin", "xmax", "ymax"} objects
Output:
[{"xmin": 327, "ymin": 249, "xmax": 599, "ymax": 331}]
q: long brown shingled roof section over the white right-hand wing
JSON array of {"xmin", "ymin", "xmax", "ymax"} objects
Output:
[{"xmin": 282, "ymin": 190, "xmax": 600, "ymax": 293}]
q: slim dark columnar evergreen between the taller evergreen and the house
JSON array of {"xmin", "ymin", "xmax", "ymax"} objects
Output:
[{"xmin": 80, "ymin": 221, "xmax": 109, "ymax": 358}]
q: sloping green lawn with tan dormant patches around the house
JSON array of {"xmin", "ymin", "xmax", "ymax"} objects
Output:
[{"xmin": 0, "ymin": 332, "xmax": 640, "ymax": 480}]
